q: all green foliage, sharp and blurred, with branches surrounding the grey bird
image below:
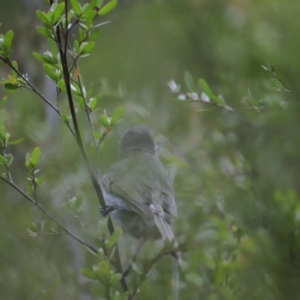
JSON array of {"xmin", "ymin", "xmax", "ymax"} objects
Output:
[{"xmin": 0, "ymin": 0, "xmax": 300, "ymax": 299}]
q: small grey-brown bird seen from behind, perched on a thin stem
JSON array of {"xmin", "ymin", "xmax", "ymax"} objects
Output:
[{"xmin": 101, "ymin": 126, "xmax": 181, "ymax": 261}]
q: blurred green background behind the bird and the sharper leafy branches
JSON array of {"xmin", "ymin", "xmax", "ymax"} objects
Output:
[{"xmin": 0, "ymin": 0, "xmax": 300, "ymax": 299}]
